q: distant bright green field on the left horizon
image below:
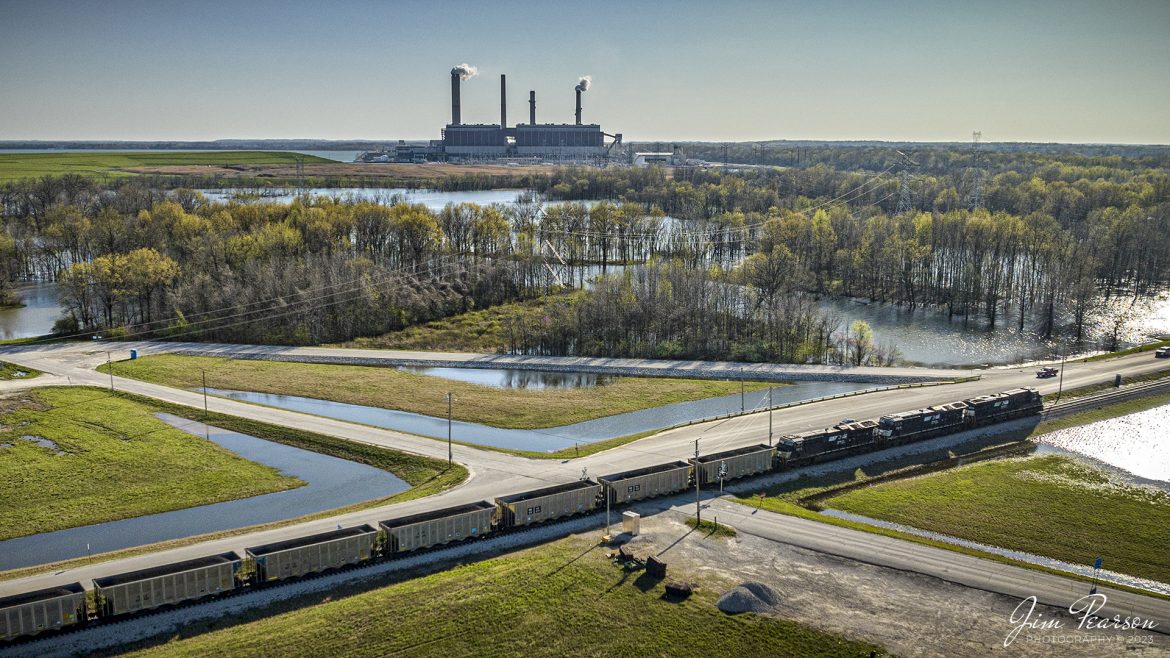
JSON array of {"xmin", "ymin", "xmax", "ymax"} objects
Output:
[{"xmin": 0, "ymin": 151, "xmax": 331, "ymax": 183}]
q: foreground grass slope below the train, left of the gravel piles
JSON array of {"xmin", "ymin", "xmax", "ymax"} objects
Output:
[{"xmin": 123, "ymin": 537, "xmax": 883, "ymax": 658}]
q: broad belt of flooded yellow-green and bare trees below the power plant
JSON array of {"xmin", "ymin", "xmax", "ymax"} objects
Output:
[{"xmin": 0, "ymin": 144, "xmax": 1170, "ymax": 363}]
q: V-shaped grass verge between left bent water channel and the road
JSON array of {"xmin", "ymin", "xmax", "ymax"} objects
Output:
[{"xmin": 0, "ymin": 389, "xmax": 468, "ymax": 580}]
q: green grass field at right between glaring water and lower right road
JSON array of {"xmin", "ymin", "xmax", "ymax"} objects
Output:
[{"xmin": 824, "ymin": 455, "xmax": 1170, "ymax": 582}]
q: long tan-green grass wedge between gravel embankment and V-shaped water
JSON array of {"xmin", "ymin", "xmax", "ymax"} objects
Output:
[{"xmin": 99, "ymin": 355, "xmax": 766, "ymax": 430}]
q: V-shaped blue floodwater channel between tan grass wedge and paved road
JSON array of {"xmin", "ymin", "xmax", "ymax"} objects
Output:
[{"xmin": 207, "ymin": 382, "xmax": 872, "ymax": 452}]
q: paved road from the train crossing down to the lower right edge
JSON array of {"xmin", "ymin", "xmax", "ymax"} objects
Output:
[{"xmin": 702, "ymin": 499, "xmax": 1170, "ymax": 631}]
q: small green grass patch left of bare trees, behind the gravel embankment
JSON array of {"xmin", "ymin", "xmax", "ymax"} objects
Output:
[{"xmin": 339, "ymin": 292, "xmax": 581, "ymax": 352}]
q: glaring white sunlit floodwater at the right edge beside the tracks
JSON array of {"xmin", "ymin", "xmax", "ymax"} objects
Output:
[{"xmin": 1034, "ymin": 405, "xmax": 1170, "ymax": 485}]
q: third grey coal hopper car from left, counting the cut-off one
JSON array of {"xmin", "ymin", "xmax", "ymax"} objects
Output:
[{"xmin": 247, "ymin": 525, "xmax": 378, "ymax": 583}]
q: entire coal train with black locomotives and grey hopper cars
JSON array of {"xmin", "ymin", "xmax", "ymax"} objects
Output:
[{"xmin": 0, "ymin": 388, "xmax": 1044, "ymax": 642}]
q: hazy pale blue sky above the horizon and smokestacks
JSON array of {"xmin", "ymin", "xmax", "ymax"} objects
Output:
[{"xmin": 0, "ymin": 0, "xmax": 1170, "ymax": 144}]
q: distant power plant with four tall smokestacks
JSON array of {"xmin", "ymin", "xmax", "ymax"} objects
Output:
[{"xmin": 362, "ymin": 64, "xmax": 621, "ymax": 163}]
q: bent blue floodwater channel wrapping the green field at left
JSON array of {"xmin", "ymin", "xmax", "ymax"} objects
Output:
[{"xmin": 0, "ymin": 413, "xmax": 410, "ymax": 570}]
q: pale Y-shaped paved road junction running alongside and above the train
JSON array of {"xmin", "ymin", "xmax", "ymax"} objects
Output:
[{"xmin": 0, "ymin": 343, "xmax": 1170, "ymax": 596}]
